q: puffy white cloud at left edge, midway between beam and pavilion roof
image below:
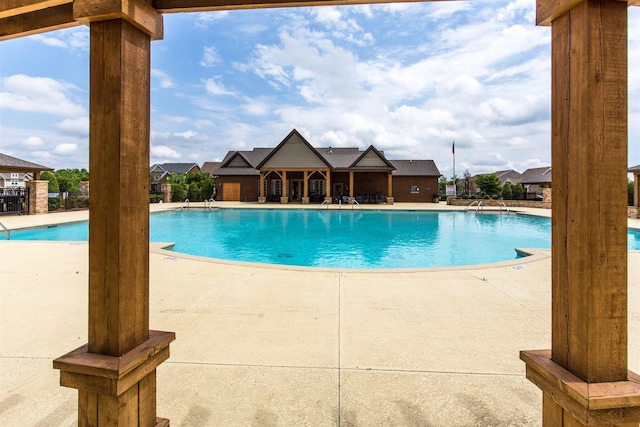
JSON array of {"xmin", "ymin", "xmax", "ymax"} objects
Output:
[{"xmin": 0, "ymin": 74, "xmax": 87, "ymax": 117}]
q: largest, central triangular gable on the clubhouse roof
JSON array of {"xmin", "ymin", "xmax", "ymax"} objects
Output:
[{"xmin": 257, "ymin": 129, "xmax": 331, "ymax": 169}]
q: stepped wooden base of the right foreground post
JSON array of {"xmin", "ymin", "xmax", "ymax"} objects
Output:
[{"xmin": 520, "ymin": 350, "xmax": 640, "ymax": 427}]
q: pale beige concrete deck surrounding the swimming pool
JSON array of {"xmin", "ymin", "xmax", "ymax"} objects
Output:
[{"xmin": 0, "ymin": 203, "xmax": 640, "ymax": 427}]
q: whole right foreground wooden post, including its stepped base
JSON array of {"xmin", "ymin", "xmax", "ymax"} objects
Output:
[{"xmin": 521, "ymin": 0, "xmax": 640, "ymax": 427}]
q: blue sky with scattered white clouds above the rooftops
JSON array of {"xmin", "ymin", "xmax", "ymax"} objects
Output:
[{"xmin": 0, "ymin": 0, "xmax": 640, "ymax": 176}]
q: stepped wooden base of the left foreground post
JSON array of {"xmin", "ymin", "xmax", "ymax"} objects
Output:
[{"xmin": 53, "ymin": 331, "xmax": 176, "ymax": 427}]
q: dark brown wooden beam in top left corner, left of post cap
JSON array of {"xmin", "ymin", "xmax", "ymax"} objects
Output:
[{"xmin": 0, "ymin": 3, "xmax": 79, "ymax": 40}]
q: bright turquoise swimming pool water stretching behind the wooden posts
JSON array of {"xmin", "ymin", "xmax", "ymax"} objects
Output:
[{"xmin": 11, "ymin": 209, "xmax": 640, "ymax": 268}]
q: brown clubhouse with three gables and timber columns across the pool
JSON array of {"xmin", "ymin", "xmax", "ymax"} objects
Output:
[{"xmin": 212, "ymin": 129, "xmax": 440, "ymax": 203}]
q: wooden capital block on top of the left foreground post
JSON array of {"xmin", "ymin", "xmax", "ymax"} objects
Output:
[{"xmin": 73, "ymin": 0, "xmax": 163, "ymax": 40}]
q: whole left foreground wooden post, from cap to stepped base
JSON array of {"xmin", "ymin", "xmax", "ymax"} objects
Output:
[{"xmin": 54, "ymin": 5, "xmax": 175, "ymax": 426}]
